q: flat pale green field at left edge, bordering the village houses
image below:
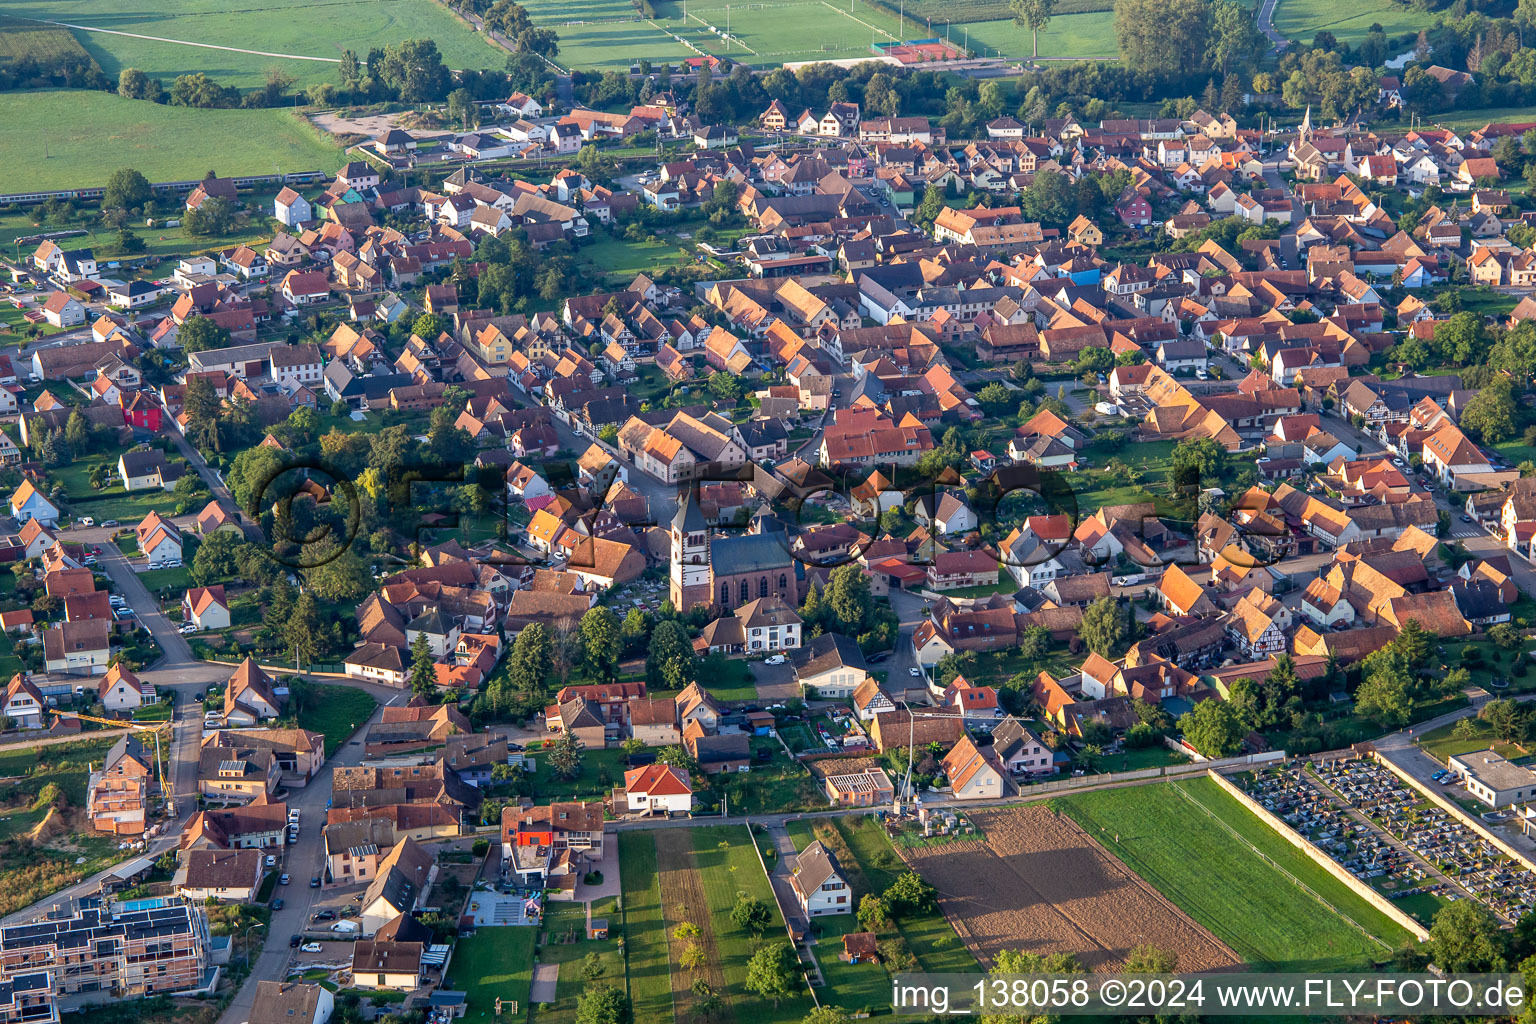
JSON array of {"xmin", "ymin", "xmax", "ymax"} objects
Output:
[{"xmin": 0, "ymin": 89, "xmax": 341, "ymax": 192}]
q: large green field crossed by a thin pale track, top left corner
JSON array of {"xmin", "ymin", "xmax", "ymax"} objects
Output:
[{"xmin": 5, "ymin": 0, "xmax": 507, "ymax": 89}]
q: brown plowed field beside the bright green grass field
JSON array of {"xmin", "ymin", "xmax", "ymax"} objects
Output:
[{"xmin": 903, "ymin": 804, "xmax": 1241, "ymax": 972}]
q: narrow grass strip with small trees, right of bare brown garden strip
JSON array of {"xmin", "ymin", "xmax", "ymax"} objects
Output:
[{"xmin": 690, "ymin": 824, "xmax": 811, "ymax": 1021}]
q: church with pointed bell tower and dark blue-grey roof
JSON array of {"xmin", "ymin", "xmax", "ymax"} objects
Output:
[{"xmin": 668, "ymin": 488, "xmax": 800, "ymax": 611}]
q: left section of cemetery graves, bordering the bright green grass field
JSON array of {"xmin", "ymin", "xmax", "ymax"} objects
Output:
[{"xmin": 1244, "ymin": 763, "xmax": 1471, "ymax": 900}]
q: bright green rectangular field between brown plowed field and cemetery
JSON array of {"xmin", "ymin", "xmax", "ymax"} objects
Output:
[{"xmin": 1052, "ymin": 778, "xmax": 1409, "ymax": 970}]
